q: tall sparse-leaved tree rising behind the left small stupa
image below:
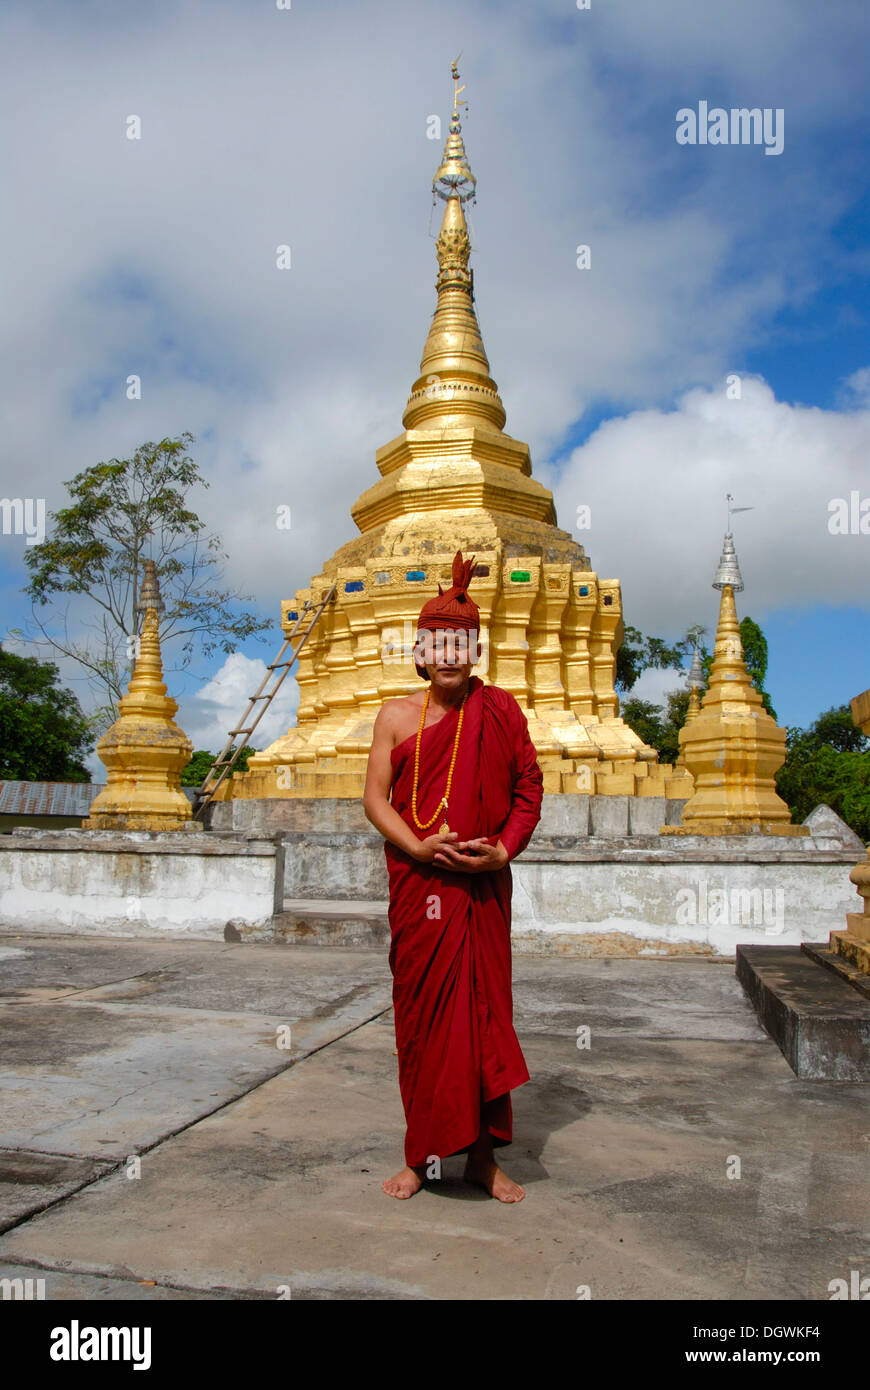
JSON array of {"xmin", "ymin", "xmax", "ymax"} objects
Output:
[{"xmin": 25, "ymin": 434, "xmax": 271, "ymax": 727}]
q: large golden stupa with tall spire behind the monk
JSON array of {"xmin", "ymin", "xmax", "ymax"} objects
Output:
[{"xmin": 226, "ymin": 68, "xmax": 692, "ymax": 799}]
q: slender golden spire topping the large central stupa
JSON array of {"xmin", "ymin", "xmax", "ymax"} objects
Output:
[{"xmin": 402, "ymin": 54, "xmax": 506, "ymax": 431}]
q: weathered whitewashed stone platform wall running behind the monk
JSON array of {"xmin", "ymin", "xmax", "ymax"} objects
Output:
[{"xmin": 0, "ymin": 795, "xmax": 866, "ymax": 956}]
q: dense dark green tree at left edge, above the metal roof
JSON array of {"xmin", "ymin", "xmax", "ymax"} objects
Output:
[{"xmin": 0, "ymin": 646, "xmax": 93, "ymax": 781}]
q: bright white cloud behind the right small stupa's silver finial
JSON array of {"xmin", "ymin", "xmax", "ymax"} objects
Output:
[{"xmin": 545, "ymin": 373, "xmax": 870, "ymax": 635}]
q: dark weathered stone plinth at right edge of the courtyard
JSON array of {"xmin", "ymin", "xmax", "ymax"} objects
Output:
[{"xmin": 737, "ymin": 945, "xmax": 870, "ymax": 1081}]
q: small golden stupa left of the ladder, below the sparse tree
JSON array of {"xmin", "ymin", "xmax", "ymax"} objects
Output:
[{"xmin": 82, "ymin": 560, "xmax": 199, "ymax": 830}]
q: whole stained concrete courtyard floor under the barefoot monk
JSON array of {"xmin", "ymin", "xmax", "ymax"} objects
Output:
[{"xmin": 0, "ymin": 935, "xmax": 870, "ymax": 1300}]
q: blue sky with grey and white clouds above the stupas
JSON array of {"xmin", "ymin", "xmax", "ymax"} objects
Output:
[{"xmin": 0, "ymin": 0, "xmax": 870, "ymax": 746}]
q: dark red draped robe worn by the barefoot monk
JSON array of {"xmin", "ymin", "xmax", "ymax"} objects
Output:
[{"xmin": 385, "ymin": 676, "xmax": 543, "ymax": 1168}]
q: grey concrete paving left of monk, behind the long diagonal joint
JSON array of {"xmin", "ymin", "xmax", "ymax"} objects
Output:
[{"xmin": 0, "ymin": 937, "xmax": 391, "ymax": 1173}]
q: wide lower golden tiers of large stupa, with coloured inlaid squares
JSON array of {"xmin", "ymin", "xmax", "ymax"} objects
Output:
[{"xmin": 225, "ymin": 533, "xmax": 692, "ymax": 798}]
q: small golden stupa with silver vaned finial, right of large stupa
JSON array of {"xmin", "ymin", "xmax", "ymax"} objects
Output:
[{"xmin": 660, "ymin": 531, "xmax": 809, "ymax": 835}]
